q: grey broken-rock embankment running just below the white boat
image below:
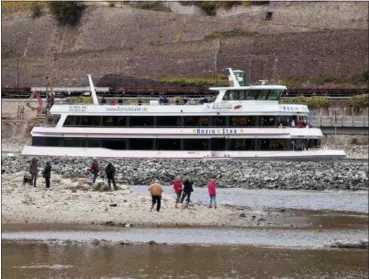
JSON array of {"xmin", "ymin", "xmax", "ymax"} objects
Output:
[{"xmin": 1, "ymin": 156, "xmax": 368, "ymax": 190}]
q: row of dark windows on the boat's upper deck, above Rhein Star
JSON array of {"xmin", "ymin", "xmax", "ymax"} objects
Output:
[{"xmin": 63, "ymin": 115, "xmax": 302, "ymax": 127}]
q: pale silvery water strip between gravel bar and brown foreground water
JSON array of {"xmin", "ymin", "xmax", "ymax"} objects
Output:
[{"xmin": 2, "ymin": 228, "xmax": 368, "ymax": 248}]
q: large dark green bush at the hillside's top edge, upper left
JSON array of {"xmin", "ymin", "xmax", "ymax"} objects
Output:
[{"xmin": 49, "ymin": 1, "xmax": 85, "ymax": 25}]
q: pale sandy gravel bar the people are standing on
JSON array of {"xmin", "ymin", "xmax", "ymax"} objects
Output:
[{"xmin": 2, "ymin": 173, "xmax": 308, "ymax": 230}]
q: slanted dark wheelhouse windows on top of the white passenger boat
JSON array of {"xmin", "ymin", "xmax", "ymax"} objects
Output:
[{"xmin": 223, "ymin": 89, "xmax": 283, "ymax": 101}]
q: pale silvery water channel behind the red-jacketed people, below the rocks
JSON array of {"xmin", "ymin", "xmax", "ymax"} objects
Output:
[{"xmin": 132, "ymin": 186, "xmax": 368, "ymax": 213}]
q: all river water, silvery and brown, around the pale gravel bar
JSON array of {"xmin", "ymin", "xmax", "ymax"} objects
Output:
[{"xmin": 2, "ymin": 186, "xmax": 368, "ymax": 279}]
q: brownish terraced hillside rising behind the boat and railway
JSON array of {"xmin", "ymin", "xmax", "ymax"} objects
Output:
[{"xmin": 2, "ymin": 2, "xmax": 368, "ymax": 87}]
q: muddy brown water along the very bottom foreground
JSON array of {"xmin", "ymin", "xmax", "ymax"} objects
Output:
[{"xmin": 2, "ymin": 242, "xmax": 368, "ymax": 279}]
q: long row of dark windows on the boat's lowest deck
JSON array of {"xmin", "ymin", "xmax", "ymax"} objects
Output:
[{"xmin": 32, "ymin": 137, "xmax": 320, "ymax": 151}]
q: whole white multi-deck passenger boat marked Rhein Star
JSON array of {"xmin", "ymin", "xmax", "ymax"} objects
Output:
[{"xmin": 22, "ymin": 68, "xmax": 345, "ymax": 160}]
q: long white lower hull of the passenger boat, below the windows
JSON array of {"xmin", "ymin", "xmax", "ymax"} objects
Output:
[{"xmin": 22, "ymin": 146, "xmax": 346, "ymax": 161}]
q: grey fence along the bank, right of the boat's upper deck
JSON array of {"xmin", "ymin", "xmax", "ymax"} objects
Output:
[{"xmin": 310, "ymin": 116, "xmax": 369, "ymax": 128}]
